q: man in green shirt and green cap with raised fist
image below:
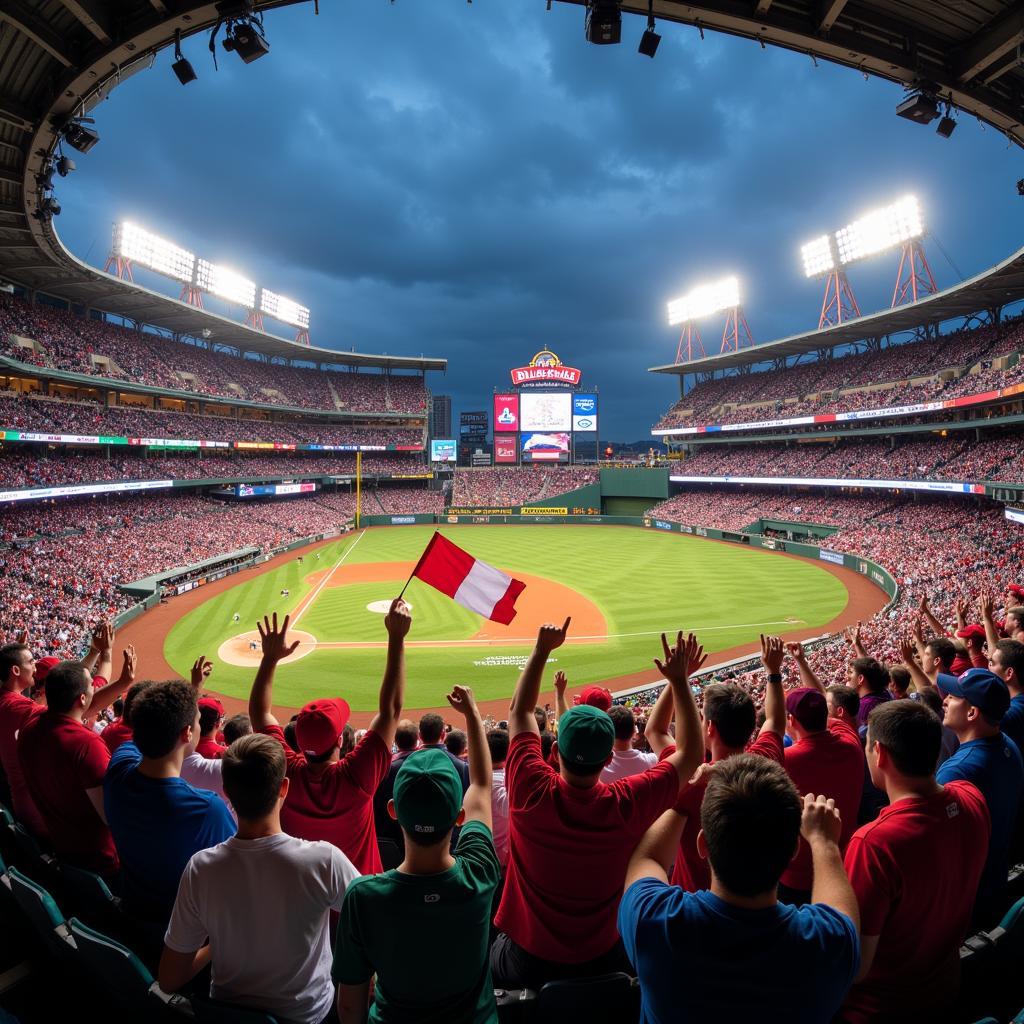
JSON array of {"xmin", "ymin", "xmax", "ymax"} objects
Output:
[{"xmin": 333, "ymin": 686, "xmax": 501, "ymax": 1024}]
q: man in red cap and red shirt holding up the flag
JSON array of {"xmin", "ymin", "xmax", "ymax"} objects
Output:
[{"xmin": 249, "ymin": 598, "xmax": 413, "ymax": 874}]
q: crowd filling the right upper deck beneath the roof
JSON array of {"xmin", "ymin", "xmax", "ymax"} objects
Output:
[{"xmin": 656, "ymin": 319, "xmax": 1024, "ymax": 427}]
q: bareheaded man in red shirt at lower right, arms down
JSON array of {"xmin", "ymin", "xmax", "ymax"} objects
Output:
[{"xmin": 841, "ymin": 700, "xmax": 991, "ymax": 1024}]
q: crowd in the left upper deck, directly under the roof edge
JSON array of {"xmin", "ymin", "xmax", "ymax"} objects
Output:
[{"xmin": 0, "ymin": 298, "xmax": 426, "ymax": 413}]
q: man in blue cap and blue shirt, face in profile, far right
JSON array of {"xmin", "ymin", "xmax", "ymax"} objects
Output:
[{"xmin": 935, "ymin": 669, "xmax": 1024, "ymax": 928}]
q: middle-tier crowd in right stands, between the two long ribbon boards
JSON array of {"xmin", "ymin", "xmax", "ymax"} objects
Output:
[{"xmin": 673, "ymin": 431, "xmax": 1024, "ymax": 481}]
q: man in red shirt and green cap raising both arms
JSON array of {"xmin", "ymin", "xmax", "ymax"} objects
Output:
[{"xmin": 490, "ymin": 618, "xmax": 703, "ymax": 988}]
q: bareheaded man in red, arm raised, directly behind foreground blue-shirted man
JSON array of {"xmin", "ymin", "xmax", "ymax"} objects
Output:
[{"xmin": 646, "ymin": 636, "xmax": 785, "ymax": 893}]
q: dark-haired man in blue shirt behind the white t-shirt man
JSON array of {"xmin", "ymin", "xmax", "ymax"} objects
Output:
[{"xmin": 103, "ymin": 681, "xmax": 236, "ymax": 942}]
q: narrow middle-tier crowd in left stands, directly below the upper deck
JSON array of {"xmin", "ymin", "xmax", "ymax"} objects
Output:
[{"xmin": 0, "ymin": 393, "xmax": 424, "ymax": 447}]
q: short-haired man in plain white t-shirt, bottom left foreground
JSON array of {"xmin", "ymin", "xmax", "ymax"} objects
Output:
[{"xmin": 159, "ymin": 733, "xmax": 358, "ymax": 1024}]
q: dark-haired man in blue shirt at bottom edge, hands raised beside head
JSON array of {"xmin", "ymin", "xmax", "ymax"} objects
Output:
[{"xmin": 618, "ymin": 754, "xmax": 860, "ymax": 1024}]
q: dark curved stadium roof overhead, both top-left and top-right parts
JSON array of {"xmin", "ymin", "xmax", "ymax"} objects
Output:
[{"xmin": 0, "ymin": 0, "xmax": 1024, "ymax": 370}]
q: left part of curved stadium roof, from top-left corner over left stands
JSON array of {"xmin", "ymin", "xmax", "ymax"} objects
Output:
[{"xmin": 0, "ymin": 0, "xmax": 447, "ymax": 371}]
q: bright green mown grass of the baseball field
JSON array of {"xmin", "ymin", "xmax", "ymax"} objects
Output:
[{"xmin": 165, "ymin": 526, "xmax": 847, "ymax": 711}]
